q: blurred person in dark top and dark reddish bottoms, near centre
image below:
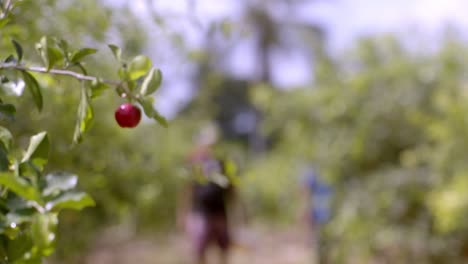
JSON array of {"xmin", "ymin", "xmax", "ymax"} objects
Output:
[{"xmin": 178, "ymin": 127, "xmax": 239, "ymax": 264}]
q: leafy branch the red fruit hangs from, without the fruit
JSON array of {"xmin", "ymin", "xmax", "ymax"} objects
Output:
[{"xmin": 0, "ymin": 37, "xmax": 167, "ymax": 143}]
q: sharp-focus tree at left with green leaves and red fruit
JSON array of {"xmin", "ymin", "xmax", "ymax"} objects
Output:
[{"xmin": 0, "ymin": 0, "xmax": 166, "ymax": 263}]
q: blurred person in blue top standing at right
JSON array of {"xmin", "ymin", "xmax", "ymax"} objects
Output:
[{"xmin": 301, "ymin": 167, "xmax": 333, "ymax": 264}]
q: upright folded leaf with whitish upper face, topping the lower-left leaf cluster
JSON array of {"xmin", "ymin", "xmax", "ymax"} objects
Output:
[{"xmin": 21, "ymin": 131, "xmax": 50, "ymax": 170}]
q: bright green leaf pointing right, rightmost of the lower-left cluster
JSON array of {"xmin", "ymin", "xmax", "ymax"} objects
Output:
[{"xmin": 45, "ymin": 192, "xmax": 96, "ymax": 211}]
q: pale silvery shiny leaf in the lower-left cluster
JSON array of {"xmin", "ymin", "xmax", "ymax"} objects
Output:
[{"xmin": 42, "ymin": 172, "xmax": 78, "ymax": 196}]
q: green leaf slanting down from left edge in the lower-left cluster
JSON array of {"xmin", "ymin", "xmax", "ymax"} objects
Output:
[{"xmin": 0, "ymin": 172, "xmax": 41, "ymax": 202}]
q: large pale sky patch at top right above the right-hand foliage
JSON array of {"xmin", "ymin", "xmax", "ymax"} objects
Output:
[{"xmin": 308, "ymin": 0, "xmax": 468, "ymax": 48}]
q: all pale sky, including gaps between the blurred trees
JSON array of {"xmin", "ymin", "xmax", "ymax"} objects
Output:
[{"xmin": 105, "ymin": 0, "xmax": 468, "ymax": 117}]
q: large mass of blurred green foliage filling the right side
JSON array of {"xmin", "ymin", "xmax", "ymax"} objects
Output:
[{"xmin": 251, "ymin": 36, "xmax": 468, "ymax": 263}]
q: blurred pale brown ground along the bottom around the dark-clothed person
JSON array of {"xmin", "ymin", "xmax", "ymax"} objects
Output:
[{"xmin": 86, "ymin": 228, "xmax": 312, "ymax": 264}]
